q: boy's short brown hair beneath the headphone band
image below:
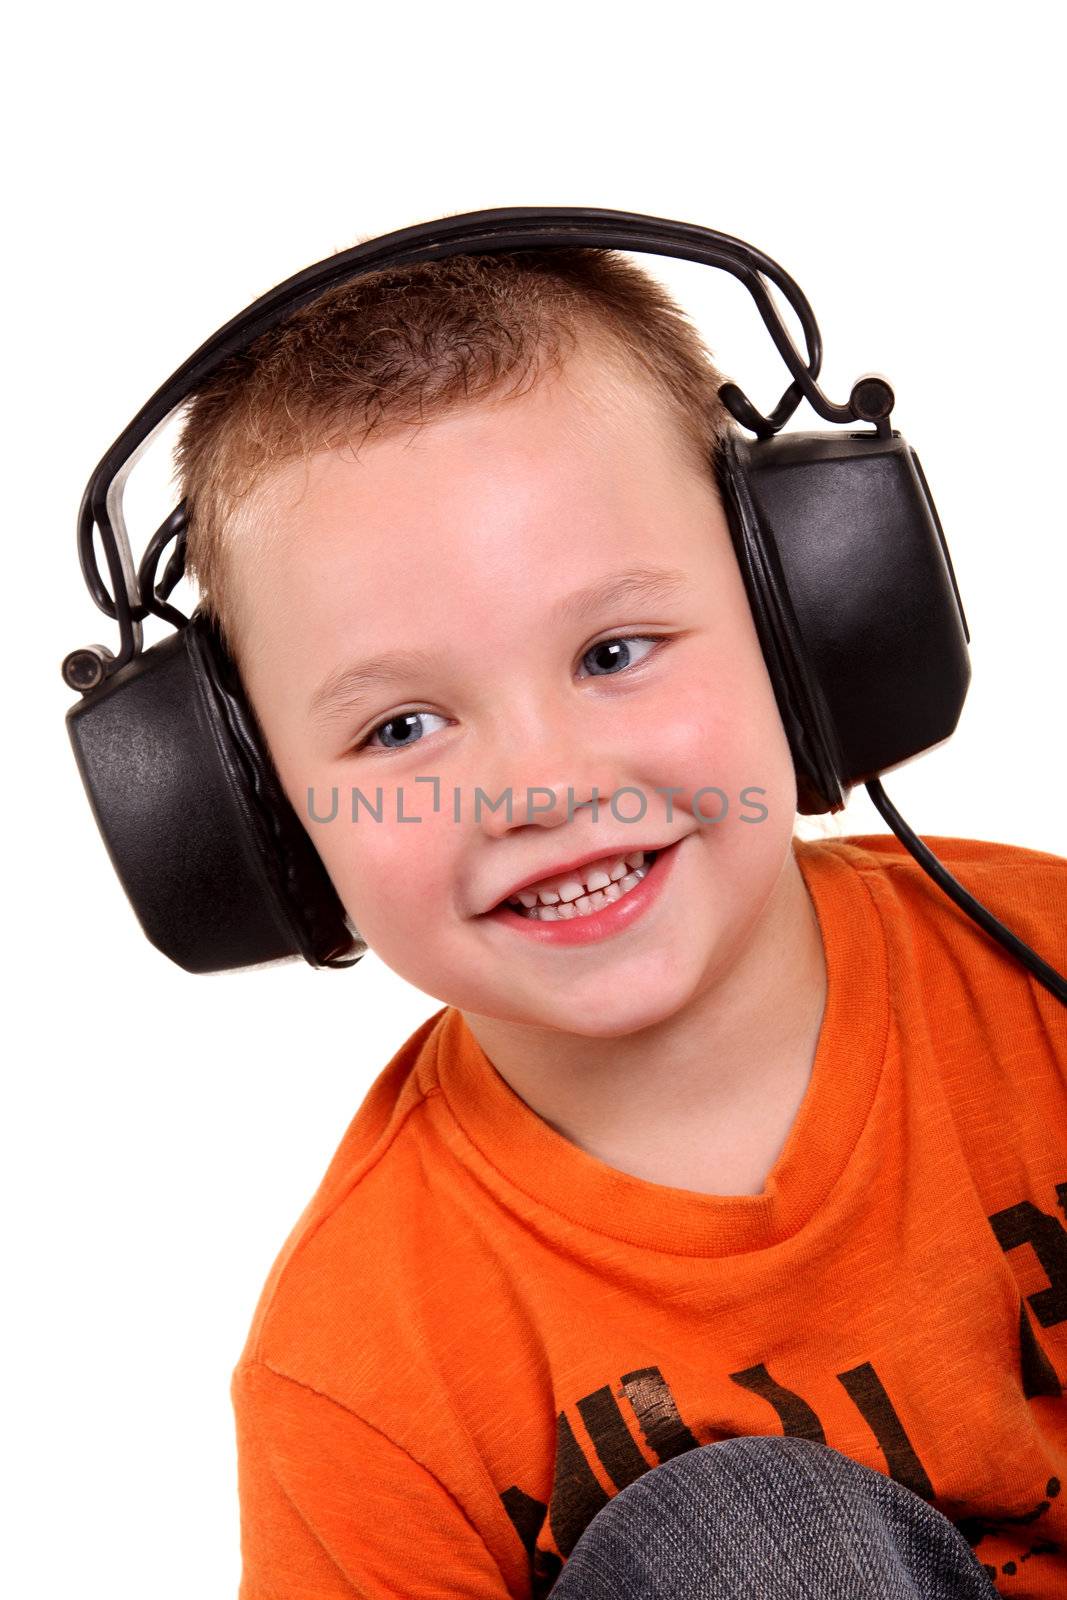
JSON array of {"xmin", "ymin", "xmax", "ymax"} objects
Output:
[{"xmin": 176, "ymin": 246, "xmax": 733, "ymax": 661}]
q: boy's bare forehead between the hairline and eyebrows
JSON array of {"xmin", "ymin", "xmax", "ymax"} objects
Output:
[{"xmin": 238, "ymin": 349, "xmax": 717, "ymax": 675}]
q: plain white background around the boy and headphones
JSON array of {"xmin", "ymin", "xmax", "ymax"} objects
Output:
[{"xmin": 2, "ymin": 0, "xmax": 1067, "ymax": 1600}]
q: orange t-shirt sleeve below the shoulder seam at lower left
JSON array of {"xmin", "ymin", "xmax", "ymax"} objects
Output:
[{"xmin": 232, "ymin": 1360, "xmax": 509, "ymax": 1600}]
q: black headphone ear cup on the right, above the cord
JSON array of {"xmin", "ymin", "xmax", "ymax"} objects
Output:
[{"xmin": 715, "ymin": 430, "xmax": 971, "ymax": 814}]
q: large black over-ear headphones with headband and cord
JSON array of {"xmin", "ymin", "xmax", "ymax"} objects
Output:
[{"xmin": 62, "ymin": 206, "xmax": 1067, "ymax": 1005}]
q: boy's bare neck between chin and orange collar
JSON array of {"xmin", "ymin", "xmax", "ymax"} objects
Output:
[{"xmin": 464, "ymin": 850, "xmax": 827, "ymax": 1194}]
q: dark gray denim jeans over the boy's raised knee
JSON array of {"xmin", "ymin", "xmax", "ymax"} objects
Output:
[{"xmin": 552, "ymin": 1435, "xmax": 997, "ymax": 1600}]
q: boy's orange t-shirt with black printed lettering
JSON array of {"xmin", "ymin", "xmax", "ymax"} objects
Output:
[{"xmin": 234, "ymin": 835, "xmax": 1067, "ymax": 1600}]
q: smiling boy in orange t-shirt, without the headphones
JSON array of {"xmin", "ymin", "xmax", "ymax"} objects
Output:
[{"xmin": 179, "ymin": 250, "xmax": 1067, "ymax": 1600}]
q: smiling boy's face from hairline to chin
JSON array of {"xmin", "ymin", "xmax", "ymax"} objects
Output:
[{"xmin": 242, "ymin": 342, "xmax": 797, "ymax": 1037}]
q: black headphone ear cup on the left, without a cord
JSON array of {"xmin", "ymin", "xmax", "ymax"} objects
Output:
[{"xmin": 67, "ymin": 611, "xmax": 366, "ymax": 973}]
